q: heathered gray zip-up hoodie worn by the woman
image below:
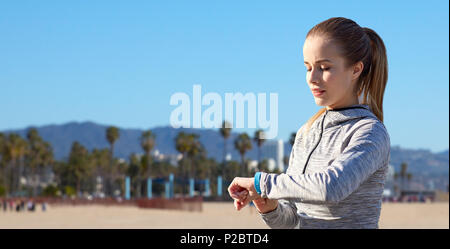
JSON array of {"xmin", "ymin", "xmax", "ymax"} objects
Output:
[{"xmin": 260, "ymin": 104, "xmax": 390, "ymax": 228}]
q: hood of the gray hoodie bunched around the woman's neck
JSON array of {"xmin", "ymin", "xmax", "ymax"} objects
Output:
[{"xmin": 324, "ymin": 104, "xmax": 378, "ymax": 129}]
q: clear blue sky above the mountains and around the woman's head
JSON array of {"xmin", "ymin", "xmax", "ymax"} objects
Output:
[{"xmin": 0, "ymin": 0, "xmax": 449, "ymax": 152}]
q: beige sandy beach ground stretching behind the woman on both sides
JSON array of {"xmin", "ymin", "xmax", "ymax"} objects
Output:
[{"xmin": 0, "ymin": 202, "xmax": 449, "ymax": 229}]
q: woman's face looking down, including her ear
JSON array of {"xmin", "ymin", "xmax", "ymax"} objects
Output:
[{"xmin": 303, "ymin": 36, "xmax": 363, "ymax": 109}]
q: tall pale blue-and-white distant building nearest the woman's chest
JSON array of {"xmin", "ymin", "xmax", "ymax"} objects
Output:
[{"xmin": 261, "ymin": 139, "xmax": 284, "ymax": 172}]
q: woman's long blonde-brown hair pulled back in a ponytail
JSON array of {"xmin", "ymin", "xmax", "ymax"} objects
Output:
[{"xmin": 305, "ymin": 17, "xmax": 388, "ymax": 134}]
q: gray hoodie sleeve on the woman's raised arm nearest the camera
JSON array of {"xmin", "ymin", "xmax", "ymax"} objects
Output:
[{"xmin": 260, "ymin": 120, "xmax": 390, "ymax": 204}]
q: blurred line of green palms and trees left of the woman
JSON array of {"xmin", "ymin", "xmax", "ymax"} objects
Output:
[{"xmin": 0, "ymin": 121, "xmax": 280, "ymax": 198}]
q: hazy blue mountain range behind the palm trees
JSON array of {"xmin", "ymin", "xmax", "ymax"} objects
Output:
[{"xmin": 3, "ymin": 122, "xmax": 449, "ymax": 176}]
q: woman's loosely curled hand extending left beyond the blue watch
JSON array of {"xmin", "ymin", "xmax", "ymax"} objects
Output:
[{"xmin": 228, "ymin": 177, "xmax": 261, "ymax": 210}]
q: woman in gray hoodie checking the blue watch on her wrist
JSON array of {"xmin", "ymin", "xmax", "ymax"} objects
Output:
[{"xmin": 228, "ymin": 17, "xmax": 390, "ymax": 228}]
